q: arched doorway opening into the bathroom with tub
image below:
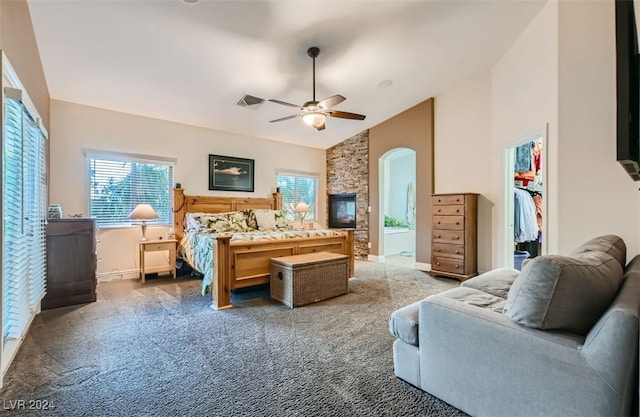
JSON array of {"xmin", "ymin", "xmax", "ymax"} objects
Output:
[{"xmin": 378, "ymin": 148, "xmax": 416, "ymax": 268}]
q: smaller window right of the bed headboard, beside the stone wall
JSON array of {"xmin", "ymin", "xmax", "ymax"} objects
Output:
[{"xmin": 277, "ymin": 172, "xmax": 318, "ymax": 221}]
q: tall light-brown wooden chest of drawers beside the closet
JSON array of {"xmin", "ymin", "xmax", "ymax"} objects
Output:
[{"xmin": 430, "ymin": 193, "xmax": 478, "ymax": 281}]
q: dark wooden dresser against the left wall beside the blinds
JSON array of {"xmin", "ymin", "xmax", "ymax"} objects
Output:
[{"xmin": 42, "ymin": 218, "xmax": 97, "ymax": 310}]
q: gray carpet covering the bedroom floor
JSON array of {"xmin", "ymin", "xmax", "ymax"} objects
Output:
[{"xmin": 0, "ymin": 261, "xmax": 465, "ymax": 417}]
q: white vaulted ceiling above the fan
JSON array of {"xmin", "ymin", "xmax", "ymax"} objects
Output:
[{"xmin": 28, "ymin": 0, "xmax": 544, "ymax": 149}]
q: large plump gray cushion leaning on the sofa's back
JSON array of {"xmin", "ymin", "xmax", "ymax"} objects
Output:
[{"xmin": 504, "ymin": 251, "xmax": 623, "ymax": 335}]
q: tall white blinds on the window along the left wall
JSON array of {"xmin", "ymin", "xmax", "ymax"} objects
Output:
[{"xmin": 2, "ymin": 97, "xmax": 46, "ymax": 342}]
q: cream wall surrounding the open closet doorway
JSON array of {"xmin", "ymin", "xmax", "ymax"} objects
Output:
[{"xmin": 435, "ymin": 1, "xmax": 640, "ymax": 271}]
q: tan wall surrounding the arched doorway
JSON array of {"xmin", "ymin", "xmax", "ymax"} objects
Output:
[{"xmin": 369, "ymin": 99, "xmax": 434, "ymax": 264}]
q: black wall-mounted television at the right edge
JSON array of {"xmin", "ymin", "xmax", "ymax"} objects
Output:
[{"xmin": 615, "ymin": 0, "xmax": 640, "ymax": 181}]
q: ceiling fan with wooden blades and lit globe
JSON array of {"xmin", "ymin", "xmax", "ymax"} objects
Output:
[{"xmin": 269, "ymin": 46, "xmax": 366, "ymax": 130}]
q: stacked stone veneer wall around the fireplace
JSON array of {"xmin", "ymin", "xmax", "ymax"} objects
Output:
[{"xmin": 326, "ymin": 130, "xmax": 369, "ymax": 259}]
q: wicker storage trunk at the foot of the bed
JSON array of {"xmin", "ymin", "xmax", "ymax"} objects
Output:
[{"xmin": 269, "ymin": 252, "xmax": 349, "ymax": 308}]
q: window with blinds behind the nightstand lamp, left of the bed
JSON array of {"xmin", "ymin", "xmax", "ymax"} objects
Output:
[{"xmin": 87, "ymin": 152, "xmax": 175, "ymax": 227}]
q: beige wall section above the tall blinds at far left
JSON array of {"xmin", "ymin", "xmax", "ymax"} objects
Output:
[{"xmin": 0, "ymin": 0, "xmax": 50, "ymax": 130}]
